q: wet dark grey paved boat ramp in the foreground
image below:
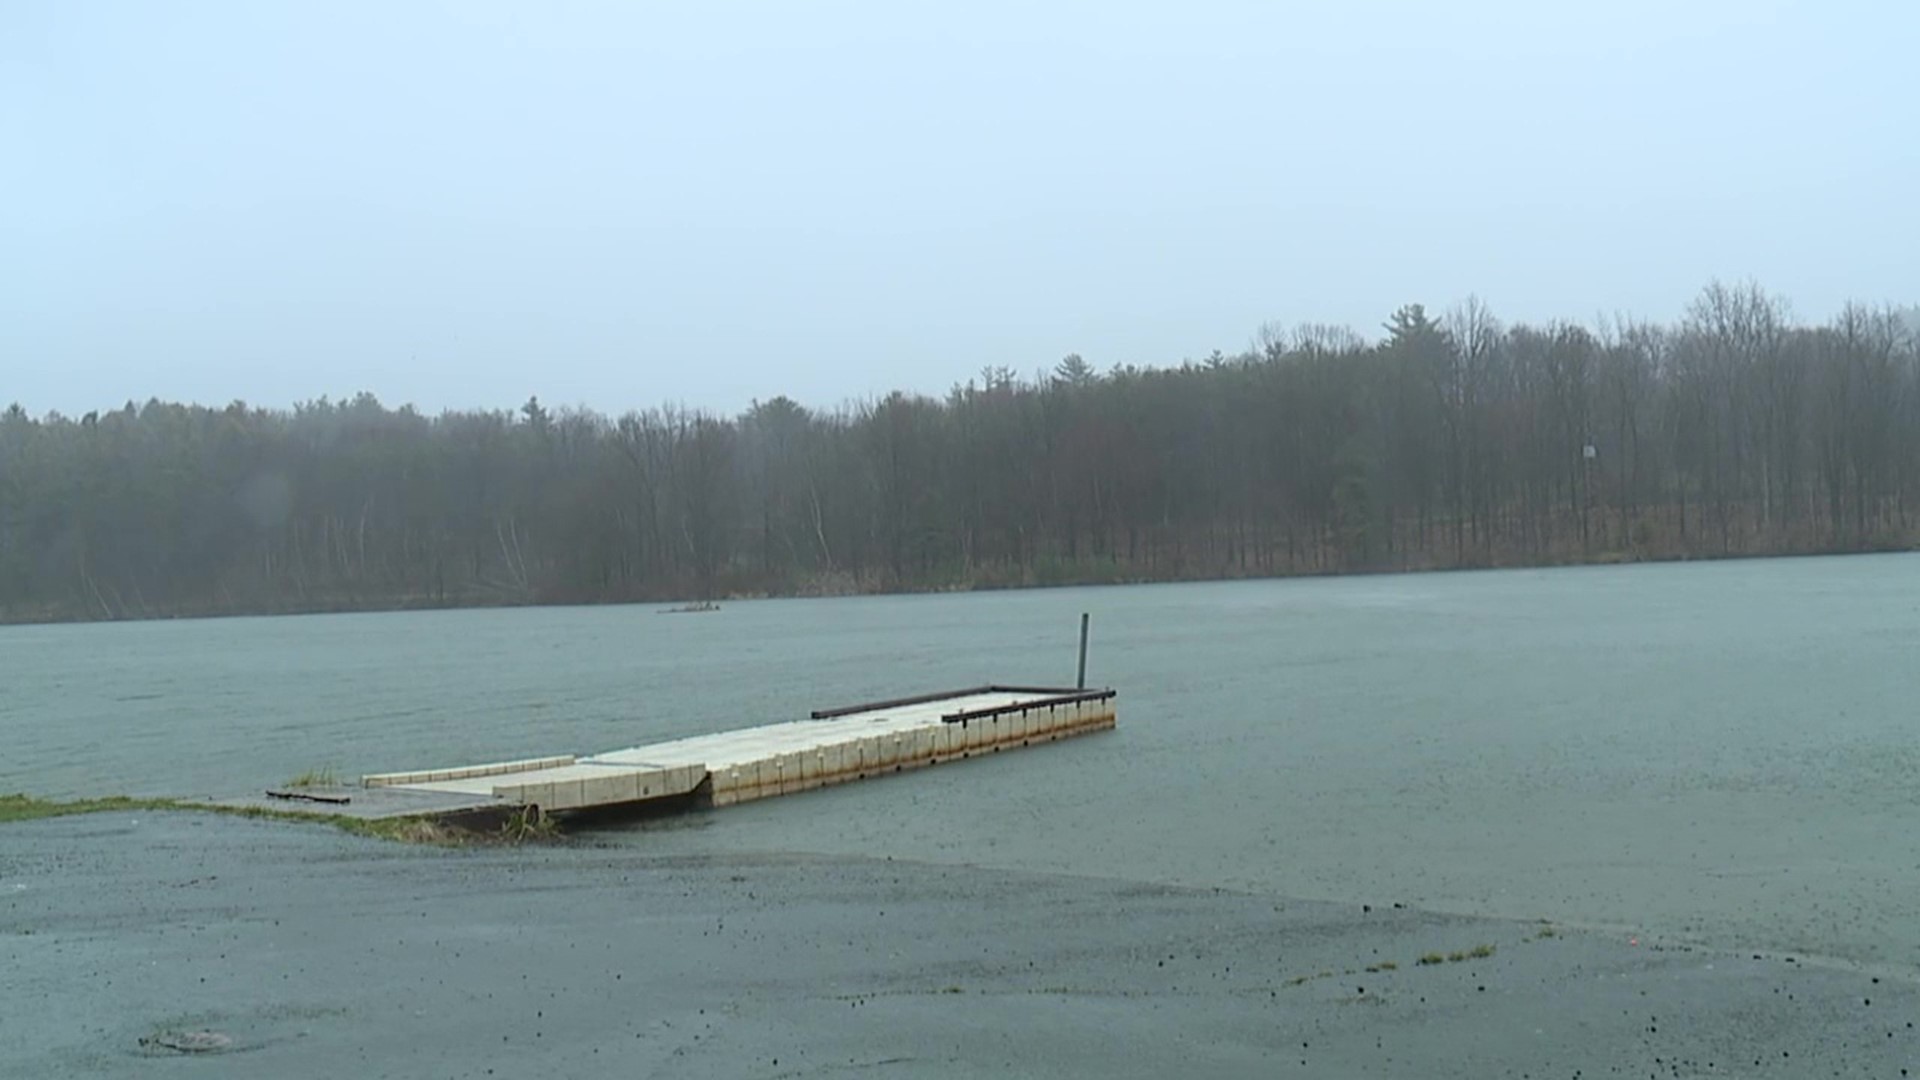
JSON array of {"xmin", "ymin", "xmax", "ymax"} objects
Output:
[{"xmin": 0, "ymin": 813, "xmax": 1920, "ymax": 1080}]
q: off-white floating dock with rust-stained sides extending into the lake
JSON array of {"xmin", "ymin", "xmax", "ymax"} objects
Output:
[{"xmin": 361, "ymin": 686, "xmax": 1116, "ymax": 811}]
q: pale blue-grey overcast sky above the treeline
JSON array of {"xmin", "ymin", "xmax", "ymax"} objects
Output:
[{"xmin": 0, "ymin": 0, "xmax": 1920, "ymax": 413}]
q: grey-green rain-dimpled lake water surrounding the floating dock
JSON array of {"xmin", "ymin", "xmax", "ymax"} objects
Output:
[{"xmin": 0, "ymin": 555, "xmax": 1920, "ymax": 965}]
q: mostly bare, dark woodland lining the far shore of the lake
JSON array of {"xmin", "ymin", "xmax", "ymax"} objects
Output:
[{"xmin": 0, "ymin": 284, "xmax": 1920, "ymax": 621}]
